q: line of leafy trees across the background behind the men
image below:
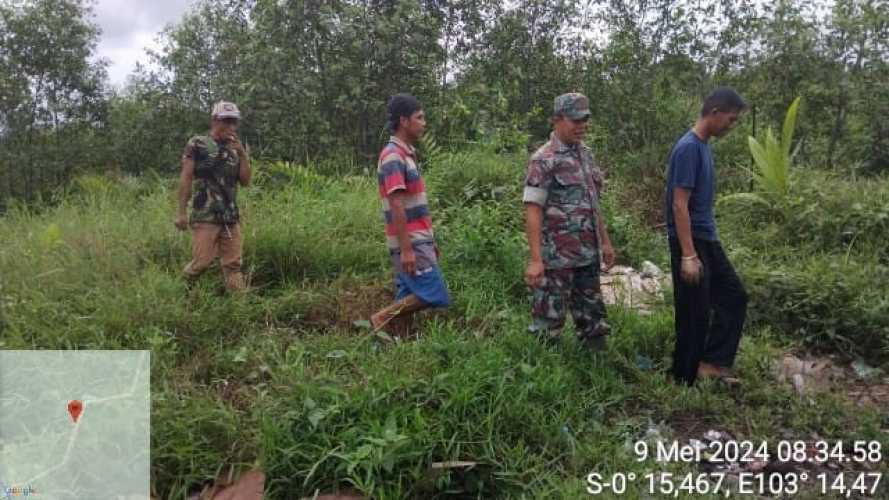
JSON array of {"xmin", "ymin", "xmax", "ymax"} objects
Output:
[{"xmin": 0, "ymin": 0, "xmax": 889, "ymax": 205}]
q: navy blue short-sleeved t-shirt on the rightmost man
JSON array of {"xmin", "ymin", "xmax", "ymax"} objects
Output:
[{"xmin": 664, "ymin": 130, "xmax": 719, "ymax": 241}]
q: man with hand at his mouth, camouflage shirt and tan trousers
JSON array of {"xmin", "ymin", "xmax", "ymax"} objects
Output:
[{"xmin": 175, "ymin": 101, "xmax": 250, "ymax": 290}]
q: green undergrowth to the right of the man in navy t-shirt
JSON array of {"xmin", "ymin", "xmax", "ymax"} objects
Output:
[{"xmin": 718, "ymin": 169, "xmax": 889, "ymax": 364}]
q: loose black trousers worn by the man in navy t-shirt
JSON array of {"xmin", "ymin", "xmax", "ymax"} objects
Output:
[{"xmin": 670, "ymin": 238, "xmax": 747, "ymax": 385}]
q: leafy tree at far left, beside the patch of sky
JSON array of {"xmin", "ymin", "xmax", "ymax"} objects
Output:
[{"xmin": 0, "ymin": 0, "xmax": 106, "ymax": 203}]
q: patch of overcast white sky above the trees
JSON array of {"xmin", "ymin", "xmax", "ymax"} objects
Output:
[{"xmin": 94, "ymin": 0, "xmax": 191, "ymax": 85}]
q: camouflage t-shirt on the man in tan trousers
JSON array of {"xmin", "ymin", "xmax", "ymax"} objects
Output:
[{"xmin": 182, "ymin": 135, "xmax": 241, "ymax": 224}]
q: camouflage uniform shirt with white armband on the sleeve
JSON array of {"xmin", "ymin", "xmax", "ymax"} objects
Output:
[{"xmin": 523, "ymin": 134, "xmax": 603, "ymax": 269}]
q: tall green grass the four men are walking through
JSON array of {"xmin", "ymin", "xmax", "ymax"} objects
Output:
[{"xmin": 0, "ymin": 153, "xmax": 887, "ymax": 499}]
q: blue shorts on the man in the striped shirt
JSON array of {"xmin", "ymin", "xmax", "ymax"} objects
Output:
[{"xmin": 392, "ymin": 243, "xmax": 451, "ymax": 307}]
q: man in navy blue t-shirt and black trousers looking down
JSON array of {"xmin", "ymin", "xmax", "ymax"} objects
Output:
[{"xmin": 664, "ymin": 87, "xmax": 747, "ymax": 384}]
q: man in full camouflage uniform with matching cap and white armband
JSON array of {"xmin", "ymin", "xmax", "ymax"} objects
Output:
[{"xmin": 523, "ymin": 93, "xmax": 614, "ymax": 348}]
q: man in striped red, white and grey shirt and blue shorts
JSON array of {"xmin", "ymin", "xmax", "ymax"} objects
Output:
[{"xmin": 371, "ymin": 94, "xmax": 450, "ymax": 331}]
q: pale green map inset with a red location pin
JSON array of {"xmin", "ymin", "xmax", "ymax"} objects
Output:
[{"xmin": 0, "ymin": 351, "xmax": 151, "ymax": 500}]
